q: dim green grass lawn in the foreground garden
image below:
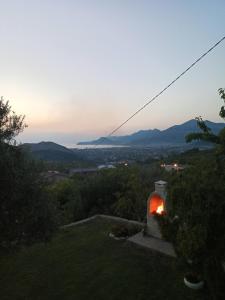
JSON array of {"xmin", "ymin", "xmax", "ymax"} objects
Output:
[{"xmin": 0, "ymin": 219, "xmax": 206, "ymax": 300}]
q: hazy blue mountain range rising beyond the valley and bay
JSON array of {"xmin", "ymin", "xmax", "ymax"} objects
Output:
[{"xmin": 78, "ymin": 120, "xmax": 225, "ymax": 146}]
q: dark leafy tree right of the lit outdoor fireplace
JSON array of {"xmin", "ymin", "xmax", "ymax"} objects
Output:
[{"xmin": 168, "ymin": 89, "xmax": 225, "ymax": 299}]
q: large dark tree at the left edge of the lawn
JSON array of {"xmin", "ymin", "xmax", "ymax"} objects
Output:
[{"xmin": 0, "ymin": 98, "xmax": 55, "ymax": 249}]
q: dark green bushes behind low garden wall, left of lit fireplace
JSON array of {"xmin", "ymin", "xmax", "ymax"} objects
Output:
[{"xmin": 48, "ymin": 163, "xmax": 162, "ymax": 224}]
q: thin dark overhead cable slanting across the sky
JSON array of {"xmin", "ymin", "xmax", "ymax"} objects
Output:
[{"xmin": 107, "ymin": 36, "xmax": 225, "ymax": 137}]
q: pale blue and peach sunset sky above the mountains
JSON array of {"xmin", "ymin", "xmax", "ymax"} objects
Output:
[{"xmin": 0, "ymin": 0, "xmax": 225, "ymax": 146}]
